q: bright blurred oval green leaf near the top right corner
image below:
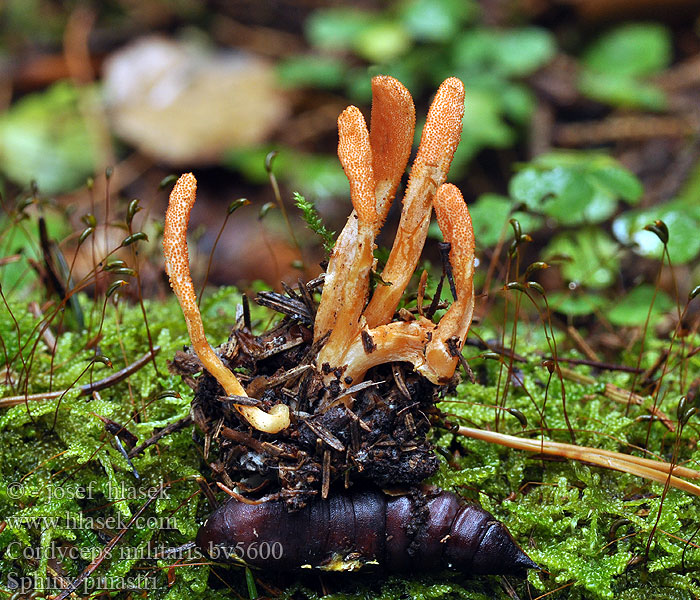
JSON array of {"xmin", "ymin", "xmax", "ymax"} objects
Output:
[{"xmin": 583, "ymin": 23, "xmax": 673, "ymax": 77}]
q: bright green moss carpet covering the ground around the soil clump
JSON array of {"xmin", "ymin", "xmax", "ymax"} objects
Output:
[{"xmin": 0, "ymin": 278, "xmax": 700, "ymax": 600}]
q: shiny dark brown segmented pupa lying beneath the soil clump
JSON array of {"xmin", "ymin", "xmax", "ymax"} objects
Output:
[{"xmin": 197, "ymin": 489, "xmax": 537, "ymax": 575}]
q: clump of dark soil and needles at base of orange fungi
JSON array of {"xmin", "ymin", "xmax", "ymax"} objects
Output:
[{"xmin": 171, "ymin": 281, "xmax": 448, "ymax": 509}]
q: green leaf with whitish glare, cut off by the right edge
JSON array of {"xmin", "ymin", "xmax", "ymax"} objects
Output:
[{"xmin": 613, "ymin": 197, "xmax": 700, "ymax": 264}]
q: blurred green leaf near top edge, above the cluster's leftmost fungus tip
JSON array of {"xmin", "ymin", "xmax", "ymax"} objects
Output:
[{"xmin": 305, "ymin": 7, "xmax": 373, "ymax": 50}]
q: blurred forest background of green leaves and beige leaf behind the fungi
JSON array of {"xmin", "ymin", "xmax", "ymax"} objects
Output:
[{"xmin": 0, "ymin": 0, "xmax": 700, "ymax": 328}]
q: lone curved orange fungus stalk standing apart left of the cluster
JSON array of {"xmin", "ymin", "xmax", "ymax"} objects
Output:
[{"xmin": 163, "ymin": 173, "xmax": 289, "ymax": 433}]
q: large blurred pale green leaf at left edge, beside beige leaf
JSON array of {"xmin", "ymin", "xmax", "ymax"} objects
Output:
[{"xmin": 0, "ymin": 81, "xmax": 97, "ymax": 193}]
